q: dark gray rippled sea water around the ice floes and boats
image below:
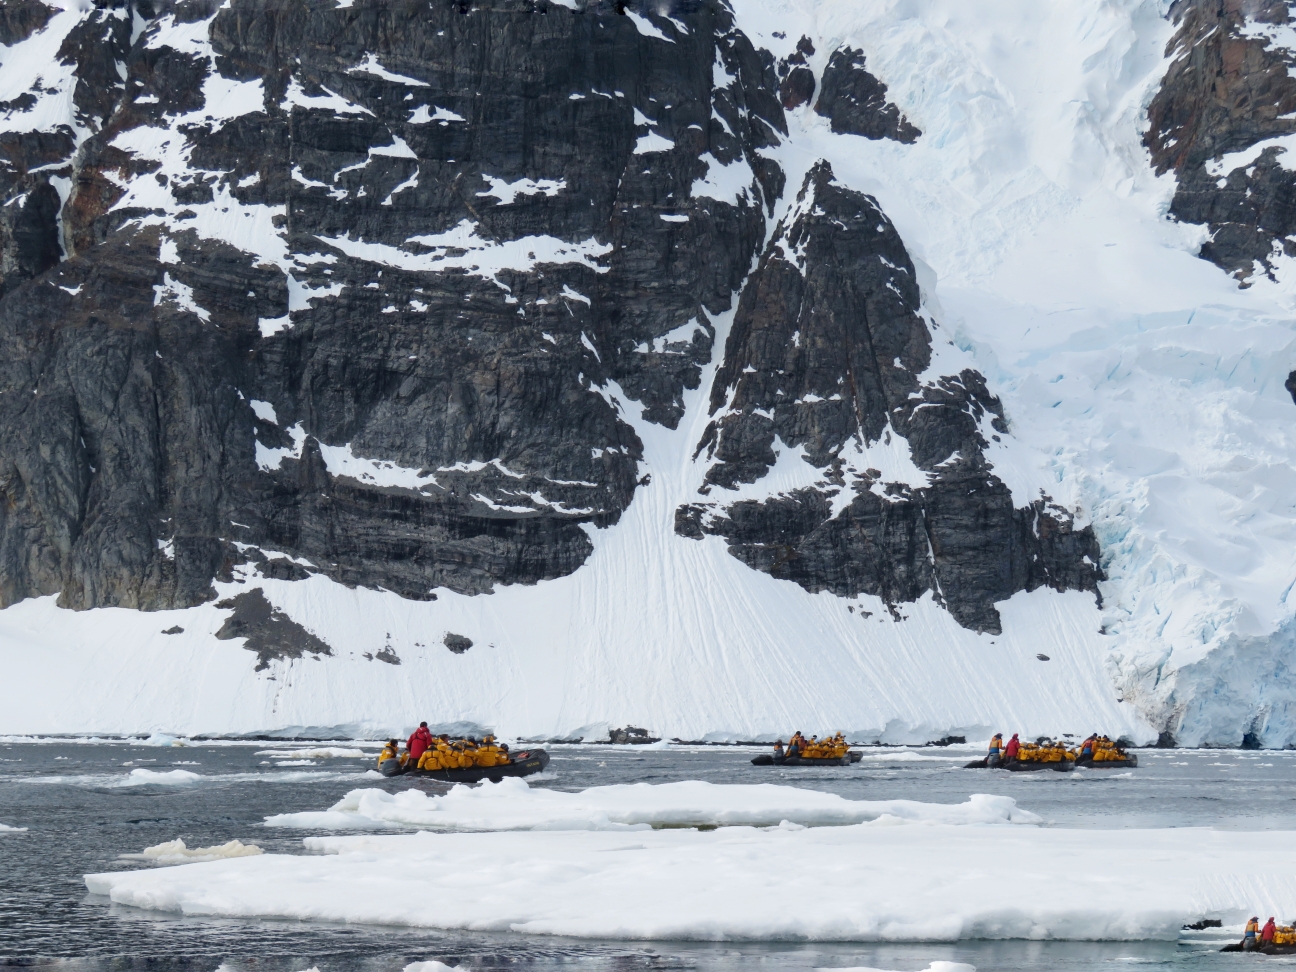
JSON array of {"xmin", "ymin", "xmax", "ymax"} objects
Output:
[{"xmin": 0, "ymin": 741, "xmax": 1296, "ymax": 972}]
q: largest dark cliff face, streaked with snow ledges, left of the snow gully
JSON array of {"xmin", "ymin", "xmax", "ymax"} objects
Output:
[{"xmin": 0, "ymin": 0, "xmax": 784, "ymax": 609}]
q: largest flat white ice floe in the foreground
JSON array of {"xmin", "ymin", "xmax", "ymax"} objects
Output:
[{"xmin": 86, "ymin": 818, "xmax": 1296, "ymax": 941}]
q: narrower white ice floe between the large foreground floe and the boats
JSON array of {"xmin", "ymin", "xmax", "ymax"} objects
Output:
[{"xmin": 266, "ymin": 778, "xmax": 1042, "ymax": 831}]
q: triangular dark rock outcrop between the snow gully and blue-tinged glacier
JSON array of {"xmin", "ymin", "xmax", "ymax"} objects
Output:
[{"xmin": 675, "ymin": 162, "xmax": 1102, "ymax": 632}]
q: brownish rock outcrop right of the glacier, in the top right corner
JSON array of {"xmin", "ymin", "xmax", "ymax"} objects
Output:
[{"xmin": 1144, "ymin": 0, "xmax": 1296, "ymax": 281}]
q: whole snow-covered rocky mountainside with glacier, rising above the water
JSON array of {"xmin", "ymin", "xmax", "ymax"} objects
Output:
[{"xmin": 0, "ymin": 0, "xmax": 1296, "ymax": 745}]
